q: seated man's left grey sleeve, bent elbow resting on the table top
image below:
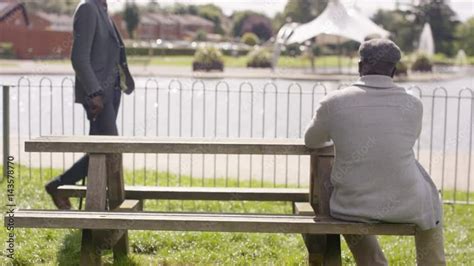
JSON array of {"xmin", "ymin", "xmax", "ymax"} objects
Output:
[{"xmin": 304, "ymin": 102, "xmax": 330, "ymax": 148}]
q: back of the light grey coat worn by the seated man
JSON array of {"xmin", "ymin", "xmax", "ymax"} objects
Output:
[{"xmin": 306, "ymin": 75, "xmax": 439, "ymax": 231}]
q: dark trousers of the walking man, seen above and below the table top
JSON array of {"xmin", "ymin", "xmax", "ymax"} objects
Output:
[{"xmin": 48, "ymin": 89, "xmax": 121, "ymax": 187}]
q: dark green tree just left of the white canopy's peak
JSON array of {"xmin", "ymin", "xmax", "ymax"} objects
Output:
[{"xmin": 283, "ymin": 0, "xmax": 329, "ymax": 23}]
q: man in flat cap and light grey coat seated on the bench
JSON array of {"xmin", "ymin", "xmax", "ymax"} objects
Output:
[{"xmin": 305, "ymin": 39, "xmax": 446, "ymax": 265}]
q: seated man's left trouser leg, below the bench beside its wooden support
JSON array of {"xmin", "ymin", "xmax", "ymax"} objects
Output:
[{"xmin": 344, "ymin": 235, "xmax": 388, "ymax": 266}]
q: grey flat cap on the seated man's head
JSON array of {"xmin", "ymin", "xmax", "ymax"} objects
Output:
[{"xmin": 359, "ymin": 39, "xmax": 402, "ymax": 65}]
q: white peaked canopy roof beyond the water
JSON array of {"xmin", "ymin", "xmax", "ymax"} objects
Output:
[{"xmin": 287, "ymin": 0, "xmax": 390, "ymax": 44}]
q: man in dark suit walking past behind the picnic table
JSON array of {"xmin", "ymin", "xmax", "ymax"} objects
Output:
[{"xmin": 45, "ymin": 0, "xmax": 135, "ymax": 209}]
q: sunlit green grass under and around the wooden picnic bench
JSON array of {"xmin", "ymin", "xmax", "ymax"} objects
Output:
[{"xmin": 0, "ymin": 165, "xmax": 474, "ymax": 265}]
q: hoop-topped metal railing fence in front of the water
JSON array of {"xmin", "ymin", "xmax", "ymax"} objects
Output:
[{"xmin": 0, "ymin": 77, "xmax": 474, "ymax": 203}]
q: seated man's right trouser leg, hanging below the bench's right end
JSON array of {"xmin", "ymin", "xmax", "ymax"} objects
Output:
[{"xmin": 415, "ymin": 225, "xmax": 446, "ymax": 266}]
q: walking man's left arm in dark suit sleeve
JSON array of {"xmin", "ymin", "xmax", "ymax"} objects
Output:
[{"xmin": 71, "ymin": 3, "xmax": 102, "ymax": 96}]
